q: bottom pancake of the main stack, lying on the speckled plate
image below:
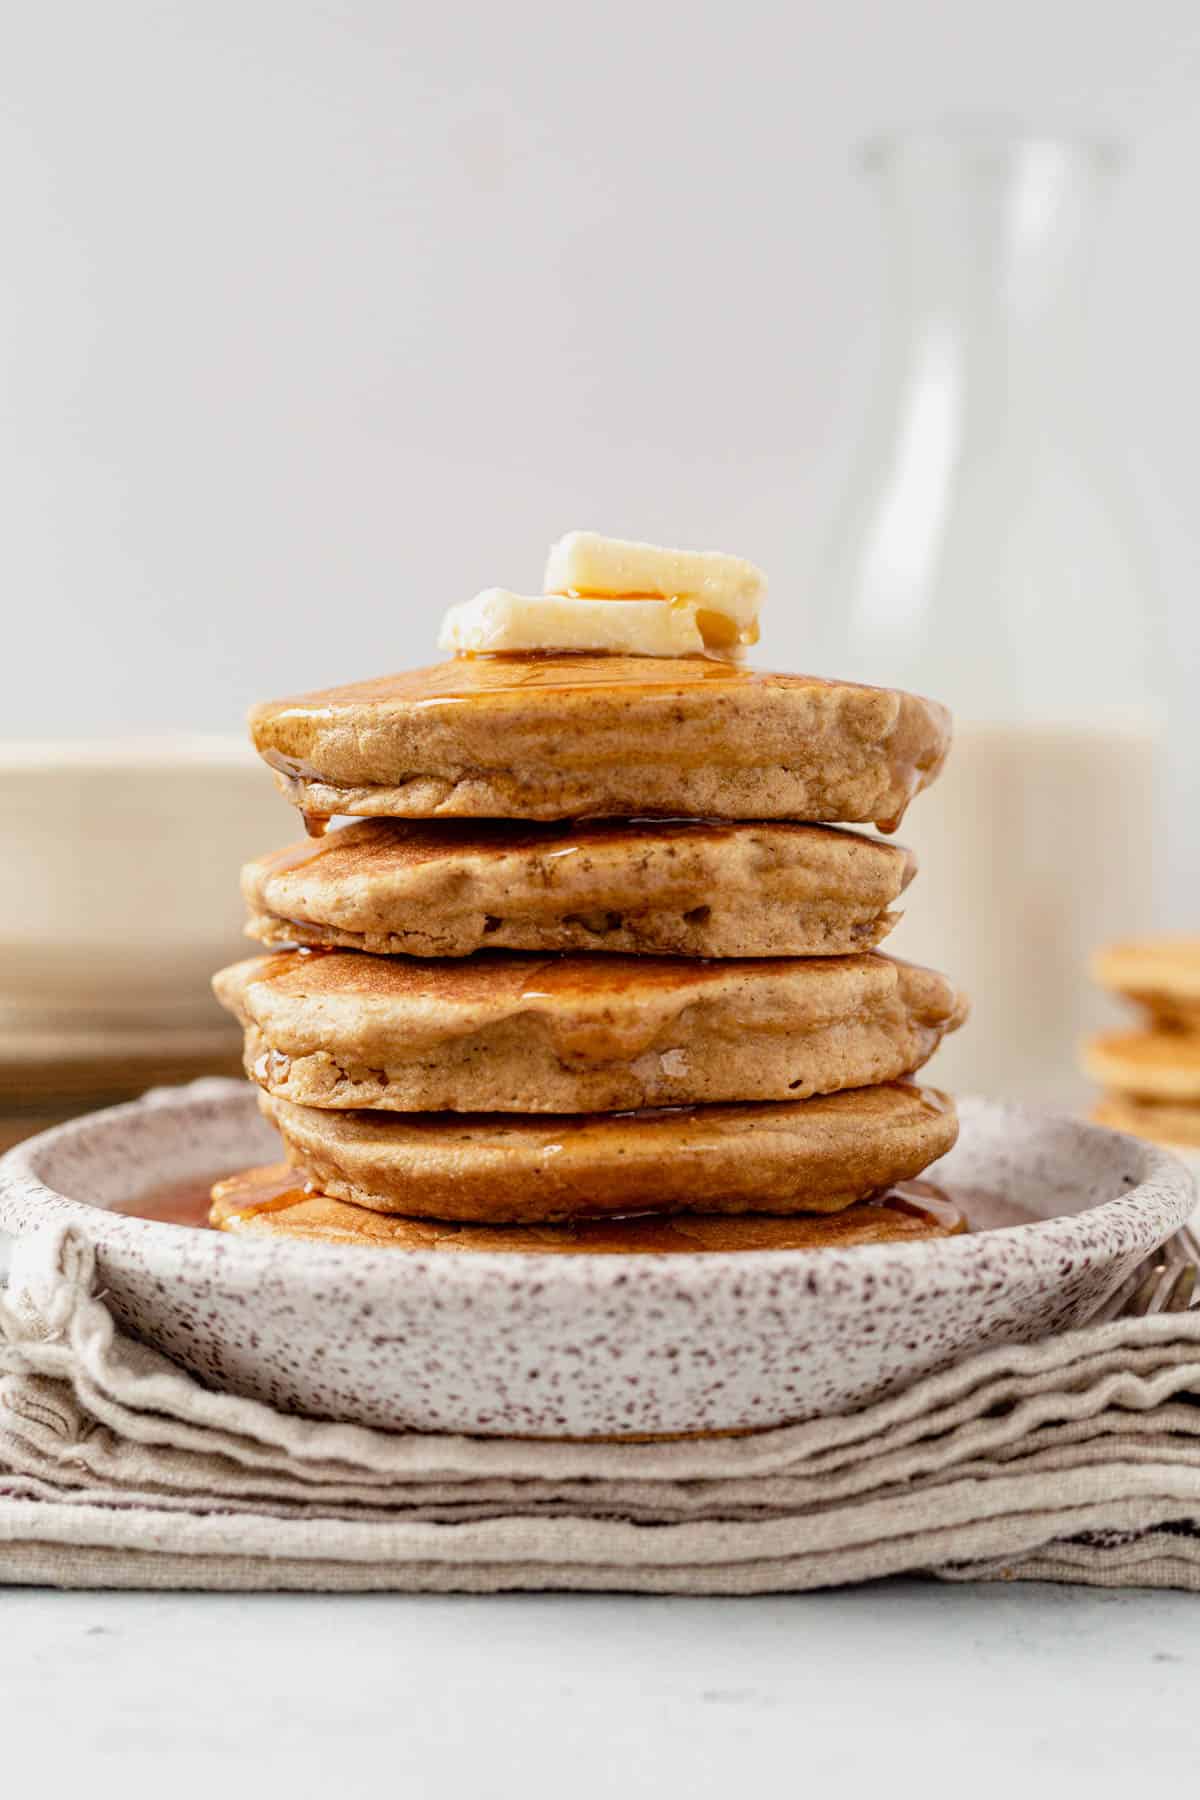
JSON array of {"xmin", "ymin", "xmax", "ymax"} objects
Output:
[{"xmin": 209, "ymin": 1163, "xmax": 966, "ymax": 1256}]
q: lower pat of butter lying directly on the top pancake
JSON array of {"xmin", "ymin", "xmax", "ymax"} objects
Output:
[{"xmin": 437, "ymin": 587, "xmax": 707, "ymax": 657}]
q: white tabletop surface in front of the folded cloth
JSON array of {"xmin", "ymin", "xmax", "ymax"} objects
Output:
[{"xmin": 0, "ymin": 1582, "xmax": 1200, "ymax": 1800}]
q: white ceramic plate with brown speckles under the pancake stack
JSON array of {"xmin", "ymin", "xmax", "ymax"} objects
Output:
[{"xmin": 0, "ymin": 1082, "xmax": 1193, "ymax": 1436}]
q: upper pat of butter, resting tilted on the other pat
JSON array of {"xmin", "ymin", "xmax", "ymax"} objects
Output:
[{"xmin": 543, "ymin": 531, "xmax": 766, "ymax": 648}]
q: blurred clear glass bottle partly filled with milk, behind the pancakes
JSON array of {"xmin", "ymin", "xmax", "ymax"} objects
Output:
[{"xmin": 811, "ymin": 130, "xmax": 1157, "ymax": 1105}]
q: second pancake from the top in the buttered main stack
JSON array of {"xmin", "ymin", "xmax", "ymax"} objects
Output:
[{"xmin": 241, "ymin": 819, "xmax": 916, "ymax": 956}]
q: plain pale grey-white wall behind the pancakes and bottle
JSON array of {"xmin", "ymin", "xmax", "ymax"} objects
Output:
[{"xmin": 0, "ymin": 0, "xmax": 1200, "ymax": 918}]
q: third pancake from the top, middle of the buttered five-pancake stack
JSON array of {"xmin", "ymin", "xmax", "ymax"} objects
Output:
[{"xmin": 214, "ymin": 950, "xmax": 966, "ymax": 1112}]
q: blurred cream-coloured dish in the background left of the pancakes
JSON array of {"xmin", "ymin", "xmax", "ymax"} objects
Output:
[{"xmin": 0, "ymin": 736, "xmax": 288, "ymax": 1031}]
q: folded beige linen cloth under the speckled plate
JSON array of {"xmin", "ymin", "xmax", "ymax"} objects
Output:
[{"xmin": 0, "ymin": 1226, "xmax": 1200, "ymax": 1593}]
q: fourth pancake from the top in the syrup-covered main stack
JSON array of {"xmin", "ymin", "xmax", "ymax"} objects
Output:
[{"xmin": 263, "ymin": 1082, "xmax": 959, "ymax": 1222}]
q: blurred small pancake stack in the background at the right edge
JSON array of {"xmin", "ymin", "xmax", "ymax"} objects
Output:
[{"xmin": 1083, "ymin": 938, "xmax": 1200, "ymax": 1156}]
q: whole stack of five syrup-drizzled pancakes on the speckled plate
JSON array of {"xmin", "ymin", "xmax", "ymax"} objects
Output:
[{"xmin": 212, "ymin": 653, "xmax": 966, "ymax": 1251}]
